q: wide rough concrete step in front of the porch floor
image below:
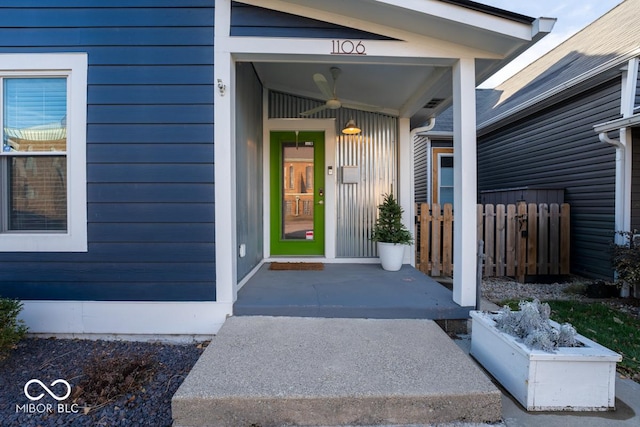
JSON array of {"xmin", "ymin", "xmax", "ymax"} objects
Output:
[{"xmin": 171, "ymin": 316, "xmax": 501, "ymax": 427}]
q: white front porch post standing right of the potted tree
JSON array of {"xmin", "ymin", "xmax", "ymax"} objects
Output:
[{"xmin": 453, "ymin": 58, "xmax": 477, "ymax": 306}]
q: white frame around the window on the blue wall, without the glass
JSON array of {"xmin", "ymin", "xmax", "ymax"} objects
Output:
[{"xmin": 0, "ymin": 53, "xmax": 88, "ymax": 252}]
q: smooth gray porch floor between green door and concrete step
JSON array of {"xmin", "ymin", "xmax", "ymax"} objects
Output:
[{"xmin": 234, "ymin": 263, "xmax": 473, "ymax": 320}]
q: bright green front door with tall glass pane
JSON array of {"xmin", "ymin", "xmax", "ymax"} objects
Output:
[{"xmin": 270, "ymin": 131, "xmax": 325, "ymax": 256}]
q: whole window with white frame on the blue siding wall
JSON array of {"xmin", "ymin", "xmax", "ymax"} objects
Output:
[{"xmin": 0, "ymin": 54, "xmax": 87, "ymax": 251}]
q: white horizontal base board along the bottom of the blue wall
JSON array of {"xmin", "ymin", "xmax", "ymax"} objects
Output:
[{"xmin": 19, "ymin": 301, "xmax": 232, "ymax": 340}]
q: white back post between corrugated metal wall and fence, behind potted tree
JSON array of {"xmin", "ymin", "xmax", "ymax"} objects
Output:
[{"xmin": 397, "ymin": 117, "xmax": 416, "ymax": 266}]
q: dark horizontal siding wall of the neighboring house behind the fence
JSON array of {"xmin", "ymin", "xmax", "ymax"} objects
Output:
[{"xmin": 478, "ymin": 79, "xmax": 620, "ymax": 278}]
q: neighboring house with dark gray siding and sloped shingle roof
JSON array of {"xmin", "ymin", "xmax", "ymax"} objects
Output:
[{"xmin": 477, "ymin": 0, "xmax": 640, "ymax": 280}]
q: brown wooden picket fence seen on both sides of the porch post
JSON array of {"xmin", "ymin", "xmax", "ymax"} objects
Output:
[{"xmin": 416, "ymin": 203, "xmax": 571, "ymax": 281}]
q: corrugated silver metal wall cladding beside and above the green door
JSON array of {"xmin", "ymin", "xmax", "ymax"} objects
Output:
[{"xmin": 269, "ymin": 92, "xmax": 398, "ymax": 258}]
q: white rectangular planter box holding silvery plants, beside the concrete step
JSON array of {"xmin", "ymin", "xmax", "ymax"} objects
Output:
[{"xmin": 470, "ymin": 311, "xmax": 622, "ymax": 411}]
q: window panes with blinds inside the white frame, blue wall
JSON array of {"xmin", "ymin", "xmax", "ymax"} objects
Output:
[{"xmin": 0, "ymin": 77, "xmax": 67, "ymax": 232}]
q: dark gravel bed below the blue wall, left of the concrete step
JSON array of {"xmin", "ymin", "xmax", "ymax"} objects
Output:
[{"xmin": 0, "ymin": 338, "xmax": 204, "ymax": 427}]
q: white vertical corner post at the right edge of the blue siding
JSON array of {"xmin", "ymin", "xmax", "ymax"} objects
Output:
[{"xmin": 214, "ymin": 0, "xmax": 237, "ymax": 308}]
